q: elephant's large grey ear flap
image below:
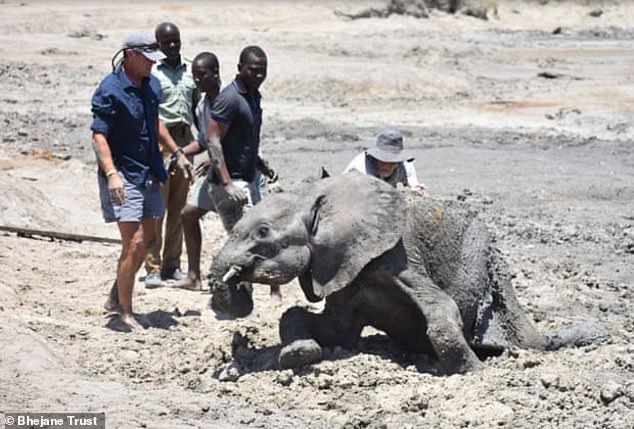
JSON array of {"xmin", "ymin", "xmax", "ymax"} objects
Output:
[{"xmin": 300, "ymin": 172, "xmax": 407, "ymax": 298}]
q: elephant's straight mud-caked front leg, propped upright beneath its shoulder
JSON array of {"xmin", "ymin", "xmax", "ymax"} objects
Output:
[{"xmin": 398, "ymin": 271, "xmax": 482, "ymax": 373}]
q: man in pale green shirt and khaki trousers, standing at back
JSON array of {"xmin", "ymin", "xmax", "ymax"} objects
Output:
[{"xmin": 145, "ymin": 22, "xmax": 200, "ymax": 288}]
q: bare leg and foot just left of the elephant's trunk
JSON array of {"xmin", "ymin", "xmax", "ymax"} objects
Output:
[{"xmin": 169, "ymin": 204, "xmax": 207, "ymax": 290}]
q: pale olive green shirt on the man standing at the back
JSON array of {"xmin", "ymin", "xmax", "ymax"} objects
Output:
[{"xmin": 152, "ymin": 58, "xmax": 200, "ymax": 128}]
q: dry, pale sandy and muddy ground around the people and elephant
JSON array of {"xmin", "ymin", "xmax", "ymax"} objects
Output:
[{"xmin": 0, "ymin": 0, "xmax": 634, "ymax": 428}]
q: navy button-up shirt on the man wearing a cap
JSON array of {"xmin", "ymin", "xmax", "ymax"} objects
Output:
[{"xmin": 90, "ymin": 66, "xmax": 167, "ymax": 188}]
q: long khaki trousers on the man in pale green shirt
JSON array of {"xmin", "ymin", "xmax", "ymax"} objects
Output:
[{"xmin": 145, "ymin": 125, "xmax": 193, "ymax": 273}]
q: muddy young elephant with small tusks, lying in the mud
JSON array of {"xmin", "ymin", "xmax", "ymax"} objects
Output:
[{"xmin": 210, "ymin": 174, "xmax": 607, "ymax": 373}]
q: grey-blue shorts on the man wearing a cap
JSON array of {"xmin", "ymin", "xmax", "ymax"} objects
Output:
[{"xmin": 97, "ymin": 173, "xmax": 165, "ymax": 222}]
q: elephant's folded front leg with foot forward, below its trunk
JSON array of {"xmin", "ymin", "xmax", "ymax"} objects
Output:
[{"xmin": 279, "ymin": 307, "xmax": 362, "ymax": 368}]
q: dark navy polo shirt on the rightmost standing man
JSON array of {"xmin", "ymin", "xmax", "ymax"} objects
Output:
[{"xmin": 211, "ymin": 78, "xmax": 262, "ymax": 184}]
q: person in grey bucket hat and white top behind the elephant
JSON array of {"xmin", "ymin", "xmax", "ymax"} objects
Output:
[{"xmin": 344, "ymin": 128, "xmax": 427, "ymax": 195}]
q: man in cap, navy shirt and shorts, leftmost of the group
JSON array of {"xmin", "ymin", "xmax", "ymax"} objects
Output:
[{"xmin": 90, "ymin": 32, "xmax": 191, "ymax": 332}]
